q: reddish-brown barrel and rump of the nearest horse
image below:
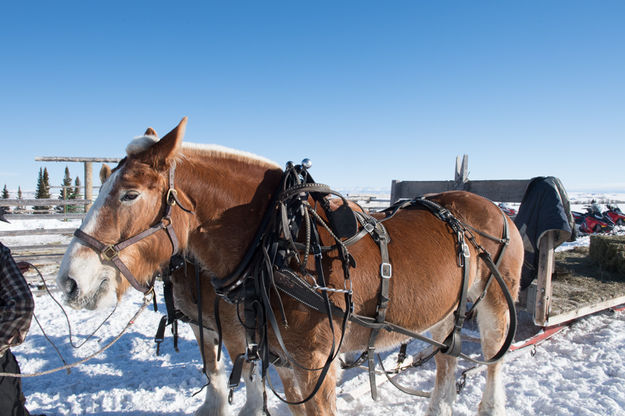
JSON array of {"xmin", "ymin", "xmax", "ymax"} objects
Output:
[{"xmin": 342, "ymin": 191, "xmax": 523, "ymax": 338}]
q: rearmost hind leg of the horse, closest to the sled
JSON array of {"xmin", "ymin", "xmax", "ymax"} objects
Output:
[{"xmin": 477, "ymin": 296, "xmax": 508, "ymax": 416}]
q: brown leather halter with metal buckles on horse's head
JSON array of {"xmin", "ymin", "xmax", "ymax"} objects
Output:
[{"xmin": 74, "ymin": 162, "xmax": 193, "ymax": 294}]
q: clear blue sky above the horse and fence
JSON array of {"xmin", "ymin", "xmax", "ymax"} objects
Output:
[{"xmin": 0, "ymin": 1, "xmax": 625, "ymax": 195}]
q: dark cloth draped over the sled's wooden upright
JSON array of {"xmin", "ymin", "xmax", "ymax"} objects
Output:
[{"xmin": 514, "ymin": 176, "xmax": 575, "ymax": 289}]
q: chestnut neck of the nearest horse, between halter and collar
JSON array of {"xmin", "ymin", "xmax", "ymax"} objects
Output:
[{"xmin": 178, "ymin": 154, "xmax": 282, "ymax": 277}]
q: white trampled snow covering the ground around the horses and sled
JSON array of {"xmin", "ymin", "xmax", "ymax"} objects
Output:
[{"xmin": 0, "ymin": 194, "xmax": 625, "ymax": 416}]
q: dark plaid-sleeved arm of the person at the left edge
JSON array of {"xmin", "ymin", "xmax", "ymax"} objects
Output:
[{"xmin": 0, "ymin": 244, "xmax": 35, "ymax": 356}]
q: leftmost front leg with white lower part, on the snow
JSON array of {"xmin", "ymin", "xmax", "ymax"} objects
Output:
[{"xmin": 191, "ymin": 325, "xmax": 230, "ymax": 416}]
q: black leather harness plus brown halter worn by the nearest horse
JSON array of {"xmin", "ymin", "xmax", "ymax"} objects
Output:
[{"xmin": 74, "ymin": 158, "xmax": 516, "ymax": 404}]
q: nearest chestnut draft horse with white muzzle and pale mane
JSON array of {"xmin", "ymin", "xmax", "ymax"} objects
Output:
[{"xmin": 57, "ymin": 118, "xmax": 523, "ymax": 415}]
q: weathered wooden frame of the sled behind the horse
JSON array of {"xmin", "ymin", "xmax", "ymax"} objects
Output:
[{"xmin": 391, "ymin": 155, "xmax": 625, "ymax": 327}]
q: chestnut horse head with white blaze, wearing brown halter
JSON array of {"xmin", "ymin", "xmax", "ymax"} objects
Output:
[{"xmin": 57, "ymin": 117, "xmax": 191, "ymax": 309}]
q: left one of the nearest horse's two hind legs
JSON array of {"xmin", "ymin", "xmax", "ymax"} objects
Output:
[{"xmin": 426, "ymin": 315, "xmax": 458, "ymax": 416}]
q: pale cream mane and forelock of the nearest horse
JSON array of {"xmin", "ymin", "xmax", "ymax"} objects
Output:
[{"xmin": 126, "ymin": 135, "xmax": 280, "ymax": 169}]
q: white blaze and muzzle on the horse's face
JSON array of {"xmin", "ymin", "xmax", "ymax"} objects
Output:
[{"xmin": 57, "ymin": 167, "xmax": 119, "ymax": 309}]
